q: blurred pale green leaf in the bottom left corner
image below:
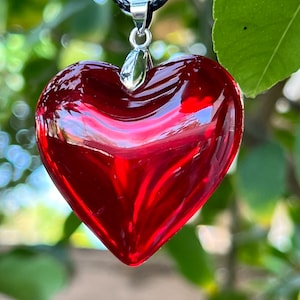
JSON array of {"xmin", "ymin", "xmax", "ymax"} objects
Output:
[{"xmin": 0, "ymin": 248, "xmax": 67, "ymax": 300}]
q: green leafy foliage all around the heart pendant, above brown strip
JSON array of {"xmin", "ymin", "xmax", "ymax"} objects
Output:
[{"xmin": 0, "ymin": 0, "xmax": 300, "ymax": 300}]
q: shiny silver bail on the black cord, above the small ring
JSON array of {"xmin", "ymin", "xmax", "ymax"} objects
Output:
[{"xmin": 130, "ymin": 0, "xmax": 150, "ymax": 35}]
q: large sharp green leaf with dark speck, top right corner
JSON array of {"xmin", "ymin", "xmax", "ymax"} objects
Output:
[{"xmin": 213, "ymin": 0, "xmax": 300, "ymax": 97}]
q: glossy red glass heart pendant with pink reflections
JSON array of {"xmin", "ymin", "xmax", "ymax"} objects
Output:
[{"xmin": 36, "ymin": 56, "xmax": 243, "ymax": 266}]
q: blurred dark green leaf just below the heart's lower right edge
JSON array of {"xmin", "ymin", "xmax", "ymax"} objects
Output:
[{"xmin": 165, "ymin": 225, "xmax": 216, "ymax": 291}]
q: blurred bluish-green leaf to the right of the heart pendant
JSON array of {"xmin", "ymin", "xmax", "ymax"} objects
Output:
[{"xmin": 237, "ymin": 143, "xmax": 286, "ymax": 221}]
